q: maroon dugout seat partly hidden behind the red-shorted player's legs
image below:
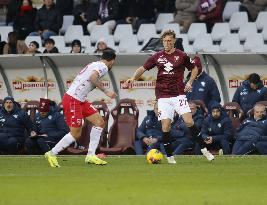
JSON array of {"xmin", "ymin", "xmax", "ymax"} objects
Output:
[{"xmin": 66, "ymin": 101, "xmax": 111, "ymax": 154}]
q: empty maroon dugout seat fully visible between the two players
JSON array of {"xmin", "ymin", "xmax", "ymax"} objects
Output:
[{"xmin": 100, "ymin": 99, "xmax": 139, "ymax": 154}]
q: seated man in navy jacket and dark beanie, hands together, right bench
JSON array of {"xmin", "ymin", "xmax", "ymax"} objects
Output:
[{"xmin": 201, "ymin": 103, "xmax": 234, "ymax": 154}]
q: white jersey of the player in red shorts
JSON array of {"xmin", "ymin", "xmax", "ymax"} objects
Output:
[{"xmin": 67, "ymin": 61, "xmax": 108, "ymax": 102}]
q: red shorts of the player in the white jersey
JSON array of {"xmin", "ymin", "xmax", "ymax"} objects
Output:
[{"xmin": 62, "ymin": 94, "xmax": 97, "ymax": 127}]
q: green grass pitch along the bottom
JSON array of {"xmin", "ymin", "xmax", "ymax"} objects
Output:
[{"xmin": 0, "ymin": 156, "xmax": 267, "ymax": 205}]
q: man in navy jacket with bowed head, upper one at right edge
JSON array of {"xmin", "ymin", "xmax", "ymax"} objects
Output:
[{"xmin": 232, "ymin": 73, "xmax": 267, "ymax": 113}]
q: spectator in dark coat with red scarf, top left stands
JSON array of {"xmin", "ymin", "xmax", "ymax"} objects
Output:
[{"xmin": 13, "ymin": 0, "xmax": 36, "ymax": 40}]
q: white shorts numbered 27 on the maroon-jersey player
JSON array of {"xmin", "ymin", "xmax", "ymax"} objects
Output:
[{"xmin": 158, "ymin": 95, "xmax": 191, "ymax": 120}]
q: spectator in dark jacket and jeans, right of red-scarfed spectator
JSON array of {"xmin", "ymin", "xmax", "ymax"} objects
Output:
[{"xmin": 30, "ymin": 0, "xmax": 63, "ymax": 40}]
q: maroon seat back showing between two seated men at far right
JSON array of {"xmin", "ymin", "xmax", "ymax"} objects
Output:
[{"xmin": 223, "ymin": 102, "xmax": 244, "ymax": 129}]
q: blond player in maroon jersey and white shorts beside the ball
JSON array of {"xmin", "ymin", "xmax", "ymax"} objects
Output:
[{"xmin": 125, "ymin": 30, "xmax": 214, "ymax": 164}]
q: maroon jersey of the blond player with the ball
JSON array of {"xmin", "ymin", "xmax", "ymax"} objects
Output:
[{"xmin": 144, "ymin": 49, "xmax": 195, "ymax": 99}]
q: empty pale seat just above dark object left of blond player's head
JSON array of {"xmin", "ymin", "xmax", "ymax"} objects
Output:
[{"xmin": 137, "ymin": 24, "xmax": 158, "ymax": 42}]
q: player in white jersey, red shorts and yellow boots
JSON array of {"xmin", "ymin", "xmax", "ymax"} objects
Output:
[{"xmin": 45, "ymin": 50, "xmax": 117, "ymax": 167}]
